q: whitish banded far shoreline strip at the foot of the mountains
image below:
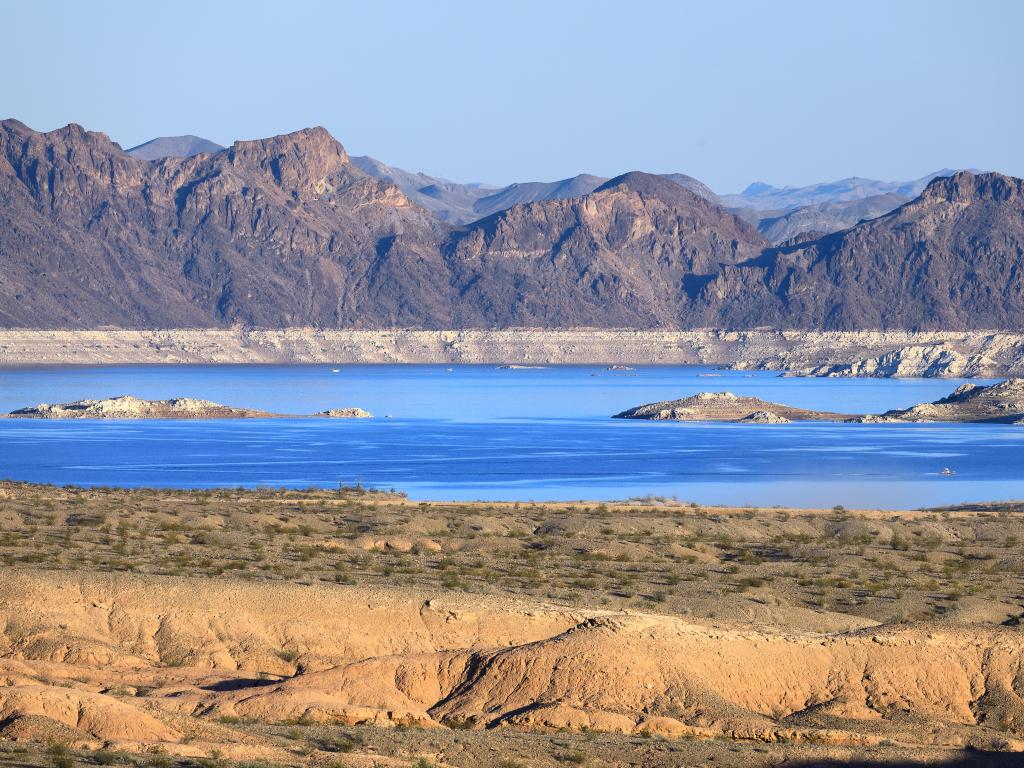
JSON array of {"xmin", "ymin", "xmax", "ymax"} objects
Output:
[{"xmin": 0, "ymin": 328, "xmax": 1024, "ymax": 378}]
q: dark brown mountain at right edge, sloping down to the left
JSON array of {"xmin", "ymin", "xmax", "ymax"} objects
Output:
[{"xmin": 700, "ymin": 171, "xmax": 1024, "ymax": 330}]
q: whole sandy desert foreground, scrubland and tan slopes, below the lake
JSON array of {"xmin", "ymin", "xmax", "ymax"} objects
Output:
[{"xmin": 0, "ymin": 483, "xmax": 1024, "ymax": 768}]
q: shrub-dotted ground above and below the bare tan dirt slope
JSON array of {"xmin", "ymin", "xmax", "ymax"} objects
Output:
[{"xmin": 0, "ymin": 482, "xmax": 1024, "ymax": 768}]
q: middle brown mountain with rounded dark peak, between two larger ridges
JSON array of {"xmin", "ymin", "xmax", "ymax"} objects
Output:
[{"xmin": 445, "ymin": 173, "xmax": 766, "ymax": 328}]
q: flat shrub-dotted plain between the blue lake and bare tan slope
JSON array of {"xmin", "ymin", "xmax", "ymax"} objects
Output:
[{"xmin": 0, "ymin": 483, "xmax": 1024, "ymax": 626}]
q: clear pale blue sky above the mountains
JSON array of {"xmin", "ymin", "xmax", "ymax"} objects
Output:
[{"xmin": 0, "ymin": 0, "xmax": 1024, "ymax": 191}]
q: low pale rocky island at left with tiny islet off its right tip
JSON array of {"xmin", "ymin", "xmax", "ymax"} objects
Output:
[{"xmin": 7, "ymin": 394, "xmax": 373, "ymax": 419}]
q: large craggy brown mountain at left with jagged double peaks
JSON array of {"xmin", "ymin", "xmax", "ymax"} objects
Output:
[{"xmin": 0, "ymin": 121, "xmax": 450, "ymax": 328}]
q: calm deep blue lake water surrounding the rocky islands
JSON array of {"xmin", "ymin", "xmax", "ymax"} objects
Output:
[{"xmin": 0, "ymin": 366, "xmax": 1024, "ymax": 508}]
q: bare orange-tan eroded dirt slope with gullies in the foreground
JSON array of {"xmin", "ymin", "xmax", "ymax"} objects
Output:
[{"xmin": 0, "ymin": 569, "xmax": 1024, "ymax": 750}]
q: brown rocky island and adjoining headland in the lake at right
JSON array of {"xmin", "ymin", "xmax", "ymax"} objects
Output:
[{"xmin": 612, "ymin": 379, "xmax": 1024, "ymax": 424}]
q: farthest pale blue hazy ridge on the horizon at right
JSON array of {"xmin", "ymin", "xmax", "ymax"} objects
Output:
[{"xmin": 719, "ymin": 168, "xmax": 955, "ymax": 211}]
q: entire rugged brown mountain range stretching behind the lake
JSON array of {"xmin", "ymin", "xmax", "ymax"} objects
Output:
[{"xmin": 0, "ymin": 120, "xmax": 1024, "ymax": 330}]
